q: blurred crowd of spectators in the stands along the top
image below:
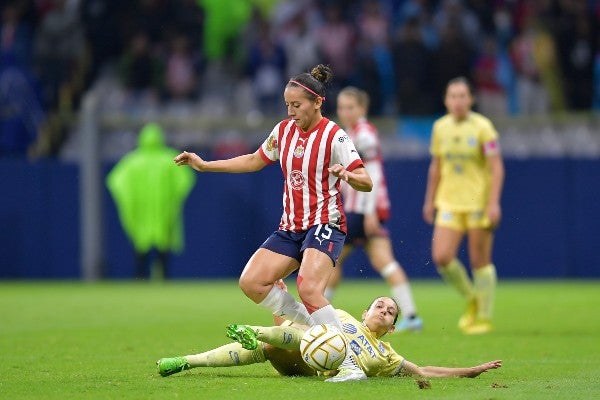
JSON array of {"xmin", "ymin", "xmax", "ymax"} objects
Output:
[{"xmin": 0, "ymin": 0, "xmax": 600, "ymax": 156}]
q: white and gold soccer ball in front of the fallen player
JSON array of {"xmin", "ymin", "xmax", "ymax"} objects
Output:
[{"xmin": 300, "ymin": 324, "xmax": 346, "ymax": 371}]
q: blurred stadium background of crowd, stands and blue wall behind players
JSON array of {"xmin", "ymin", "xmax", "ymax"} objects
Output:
[{"xmin": 0, "ymin": 0, "xmax": 600, "ymax": 279}]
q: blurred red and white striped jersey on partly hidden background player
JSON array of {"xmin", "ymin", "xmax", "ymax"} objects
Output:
[{"xmin": 341, "ymin": 118, "xmax": 391, "ymax": 221}]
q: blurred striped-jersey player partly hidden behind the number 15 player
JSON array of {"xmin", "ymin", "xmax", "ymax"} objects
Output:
[{"xmin": 325, "ymin": 87, "xmax": 423, "ymax": 332}]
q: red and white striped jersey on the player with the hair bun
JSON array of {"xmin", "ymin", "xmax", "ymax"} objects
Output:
[{"xmin": 259, "ymin": 118, "xmax": 363, "ymax": 233}]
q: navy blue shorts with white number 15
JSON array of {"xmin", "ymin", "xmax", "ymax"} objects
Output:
[{"xmin": 260, "ymin": 224, "xmax": 346, "ymax": 265}]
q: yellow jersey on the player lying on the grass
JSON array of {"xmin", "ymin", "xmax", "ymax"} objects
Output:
[{"xmin": 336, "ymin": 310, "xmax": 404, "ymax": 376}]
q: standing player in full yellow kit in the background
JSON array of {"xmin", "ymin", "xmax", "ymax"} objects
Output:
[{"xmin": 423, "ymin": 77, "xmax": 504, "ymax": 334}]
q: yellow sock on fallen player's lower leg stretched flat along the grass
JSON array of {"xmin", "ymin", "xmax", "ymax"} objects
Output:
[{"xmin": 185, "ymin": 343, "xmax": 266, "ymax": 368}]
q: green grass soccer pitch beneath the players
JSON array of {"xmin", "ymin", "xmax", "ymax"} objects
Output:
[{"xmin": 0, "ymin": 280, "xmax": 600, "ymax": 400}]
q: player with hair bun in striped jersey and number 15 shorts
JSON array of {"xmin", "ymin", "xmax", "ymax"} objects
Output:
[{"xmin": 175, "ymin": 65, "xmax": 373, "ymax": 354}]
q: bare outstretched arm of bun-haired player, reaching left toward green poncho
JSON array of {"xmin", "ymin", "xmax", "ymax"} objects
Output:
[{"xmin": 173, "ymin": 151, "xmax": 267, "ymax": 173}]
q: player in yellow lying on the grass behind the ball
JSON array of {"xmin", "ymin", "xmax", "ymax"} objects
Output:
[{"xmin": 157, "ymin": 297, "xmax": 502, "ymax": 385}]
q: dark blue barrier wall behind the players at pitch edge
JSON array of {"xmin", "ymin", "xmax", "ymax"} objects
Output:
[{"xmin": 0, "ymin": 158, "xmax": 600, "ymax": 279}]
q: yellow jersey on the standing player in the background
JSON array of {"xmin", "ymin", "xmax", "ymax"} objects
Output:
[{"xmin": 430, "ymin": 112, "xmax": 499, "ymax": 212}]
